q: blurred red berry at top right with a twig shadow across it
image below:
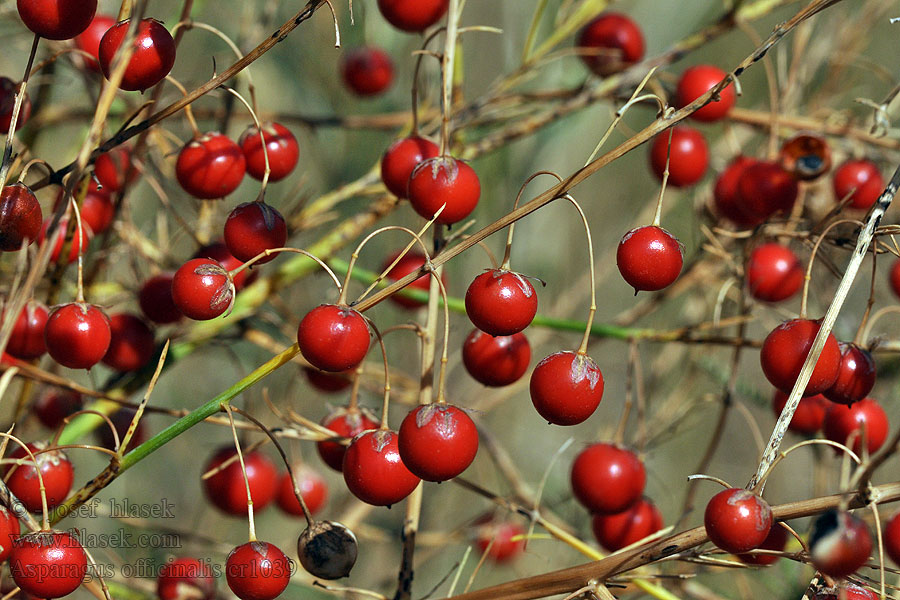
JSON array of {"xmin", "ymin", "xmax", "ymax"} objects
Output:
[{"xmin": 578, "ymin": 12, "xmax": 644, "ymax": 77}]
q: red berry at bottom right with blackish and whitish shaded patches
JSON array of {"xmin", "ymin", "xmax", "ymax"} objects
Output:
[{"xmin": 809, "ymin": 509, "xmax": 872, "ymax": 577}]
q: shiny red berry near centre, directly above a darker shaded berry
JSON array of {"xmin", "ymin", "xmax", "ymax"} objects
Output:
[{"xmin": 466, "ymin": 269, "xmax": 537, "ymax": 335}]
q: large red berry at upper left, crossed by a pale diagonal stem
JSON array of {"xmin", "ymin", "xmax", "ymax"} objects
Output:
[{"xmin": 97, "ymin": 19, "xmax": 175, "ymax": 92}]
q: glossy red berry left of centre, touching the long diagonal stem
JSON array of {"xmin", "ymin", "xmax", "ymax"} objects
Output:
[{"xmin": 297, "ymin": 304, "xmax": 369, "ymax": 373}]
